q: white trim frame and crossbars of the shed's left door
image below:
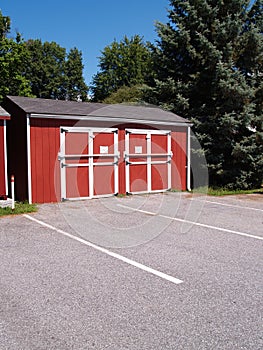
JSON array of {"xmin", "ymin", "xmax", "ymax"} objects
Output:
[{"xmin": 58, "ymin": 126, "xmax": 119, "ymax": 201}]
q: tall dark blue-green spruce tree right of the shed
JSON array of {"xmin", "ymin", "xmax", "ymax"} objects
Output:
[{"xmin": 146, "ymin": 0, "xmax": 263, "ymax": 188}]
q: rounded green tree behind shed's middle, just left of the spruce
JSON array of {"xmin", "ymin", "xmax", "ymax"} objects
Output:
[{"xmin": 91, "ymin": 35, "xmax": 152, "ymax": 101}]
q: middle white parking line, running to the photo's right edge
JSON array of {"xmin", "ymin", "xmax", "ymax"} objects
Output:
[{"xmin": 117, "ymin": 204, "xmax": 263, "ymax": 240}]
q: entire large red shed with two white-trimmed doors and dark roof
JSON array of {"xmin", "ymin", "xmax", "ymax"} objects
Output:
[{"xmin": 3, "ymin": 96, "xmax": 191, "ymax": 203}]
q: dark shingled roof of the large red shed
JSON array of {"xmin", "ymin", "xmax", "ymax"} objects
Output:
[{"xmin": 3, "ymin": 96, "xmax": 189, "ymax": 124}]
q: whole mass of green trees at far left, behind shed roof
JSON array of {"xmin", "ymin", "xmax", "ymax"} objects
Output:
[{"xmin": 0, "ymin": 11, "xmax": 88, "ymax": 101}]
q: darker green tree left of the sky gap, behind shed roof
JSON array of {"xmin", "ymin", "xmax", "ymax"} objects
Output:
[{"xmin": 25, "ymin": 39, "xmax": 88, "ymax": 101}]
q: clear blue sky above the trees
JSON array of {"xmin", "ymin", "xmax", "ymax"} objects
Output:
[{"xmin": 0, "ymin": 0, "xmax": 169, "ymax": 84}]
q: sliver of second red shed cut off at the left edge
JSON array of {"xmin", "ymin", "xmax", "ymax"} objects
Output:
[{"xmin": 0, "ymin": 107, "xmax": 10, "ymax": 198}]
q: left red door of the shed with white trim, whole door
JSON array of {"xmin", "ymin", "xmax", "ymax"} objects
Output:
[{"xmin": 59, "ymin": 127, "xmax": 119, "ymax": 200}]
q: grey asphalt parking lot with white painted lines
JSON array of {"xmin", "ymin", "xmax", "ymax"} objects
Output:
[{"xmin": 0, "ymin": 193, "xmax": 263, "ymax": 350}]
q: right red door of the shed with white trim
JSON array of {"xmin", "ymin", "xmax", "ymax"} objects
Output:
[{"xmin": 125, "ymin": 129, "xmax": 172, "ymax": 193}]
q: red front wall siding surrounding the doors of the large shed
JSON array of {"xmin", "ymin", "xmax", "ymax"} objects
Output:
[{"xmin": 30, "ymin": 119, "xmax": 187, "ymax": 203}]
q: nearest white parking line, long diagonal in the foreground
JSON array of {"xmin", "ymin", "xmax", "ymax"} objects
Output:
[{"xmin": 24, "ymin": 214, "xmax": 183, "ymax": 284}]
